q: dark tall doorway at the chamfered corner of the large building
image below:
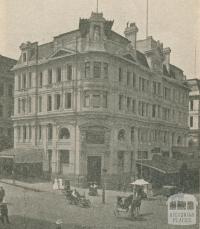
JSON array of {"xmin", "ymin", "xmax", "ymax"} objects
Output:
[{"xmin": 87, "ymin": 156, "xmax": 101, "ymax": 184}]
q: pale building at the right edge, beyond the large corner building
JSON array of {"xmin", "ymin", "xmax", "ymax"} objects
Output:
[{"xmin": 187, "ymin": 79, "xmax": 200, "ymax": 155}]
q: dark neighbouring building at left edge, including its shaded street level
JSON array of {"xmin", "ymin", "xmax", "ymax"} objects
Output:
[{"xmin": 0, "ymin": 55, "xmax": 16, "ymax": 175}]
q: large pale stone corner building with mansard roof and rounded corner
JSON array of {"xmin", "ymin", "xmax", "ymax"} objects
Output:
[{"xmin": 13, "ymin": 13, "xmax": 188, "ymax": 186}]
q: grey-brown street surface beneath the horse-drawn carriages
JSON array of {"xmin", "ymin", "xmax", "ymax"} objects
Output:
[{"xmin": 0, "ymin": 184, "xmax": 197, "ymax": 229}]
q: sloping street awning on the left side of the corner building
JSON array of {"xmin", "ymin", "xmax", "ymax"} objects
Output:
[{"xmin": 0, "ymin": 148, "xmax": 43, "ymax": 164}]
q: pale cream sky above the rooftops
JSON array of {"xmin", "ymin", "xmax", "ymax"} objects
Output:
[{"xmin": 0, "ymin": 0, "xmax": 200, "ymax": 78}]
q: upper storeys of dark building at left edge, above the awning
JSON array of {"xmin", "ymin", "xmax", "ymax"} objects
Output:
[{"xmin": 0, "ymin": 55, "xmax": 16, "ymax": 147}]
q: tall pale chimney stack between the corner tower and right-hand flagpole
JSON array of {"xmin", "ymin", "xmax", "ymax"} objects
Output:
[{"xmin": 124, "ymin": 23, "xmax": 138, "ymax": 49}]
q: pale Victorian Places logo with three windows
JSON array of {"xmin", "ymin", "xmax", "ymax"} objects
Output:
[{"xmin": 167, "ymin": 193, "xmax": 198, "ymax": 225}]
